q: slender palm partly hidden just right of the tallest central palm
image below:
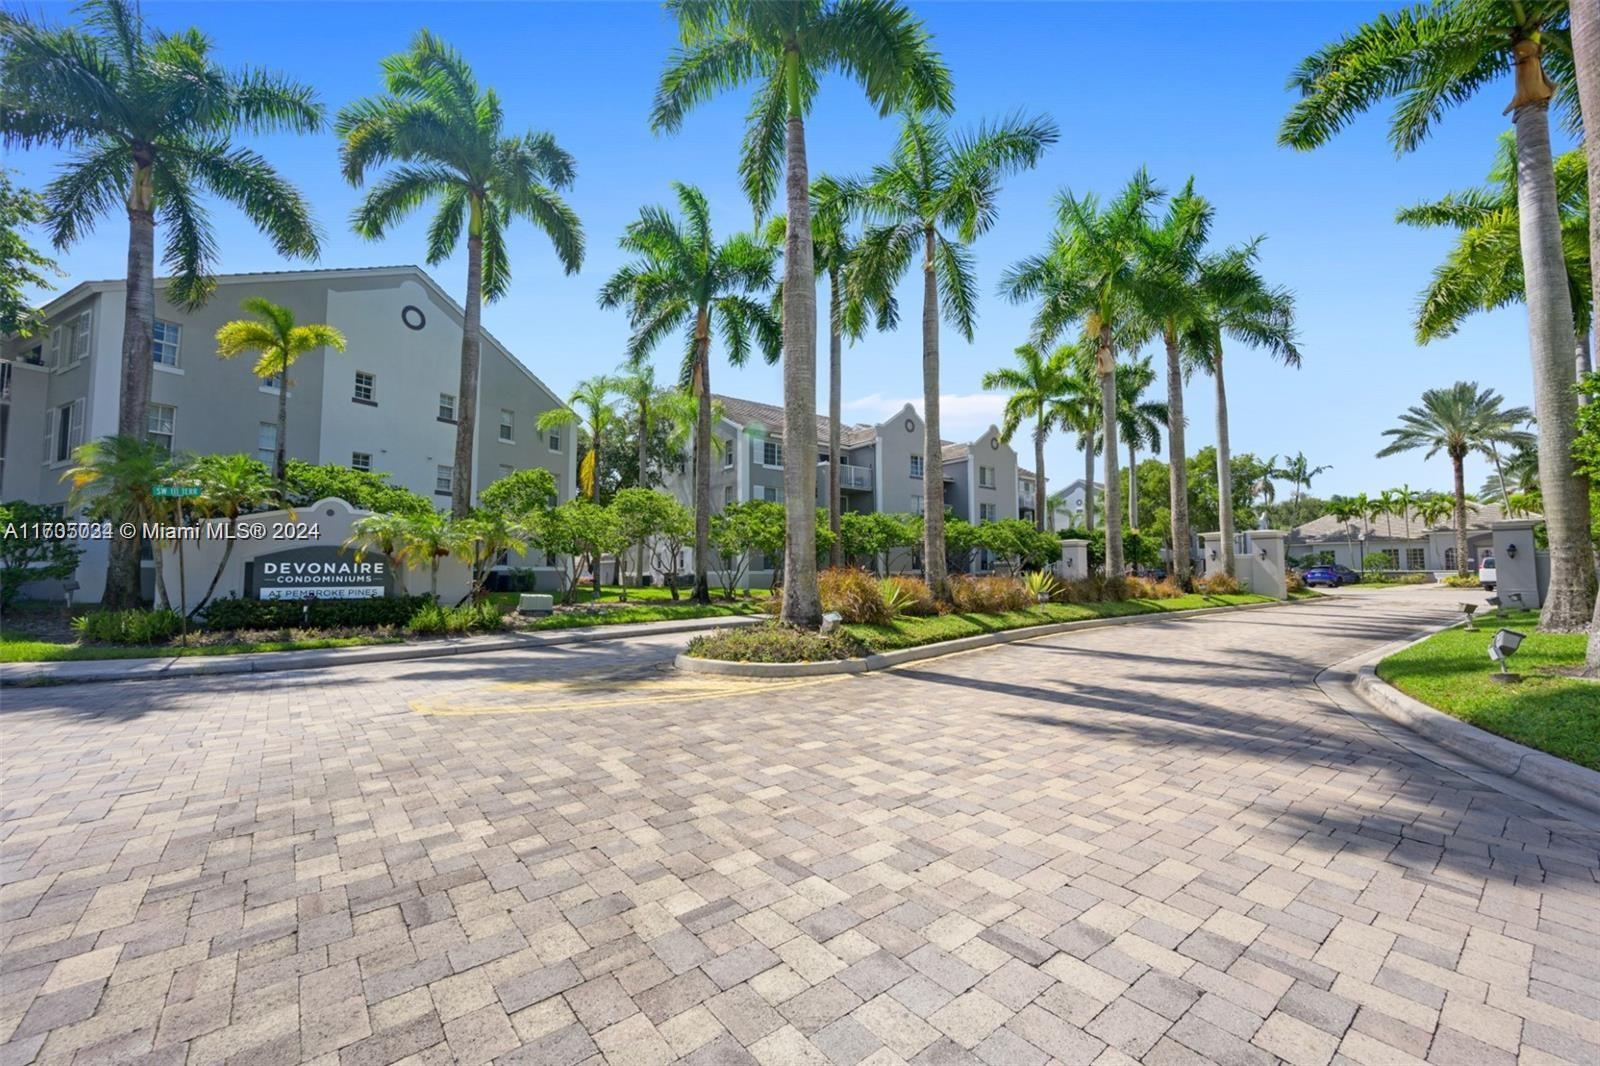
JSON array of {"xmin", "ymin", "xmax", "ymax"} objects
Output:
[{"xmin": 766, "ymin": 174, "xmax": 899, "ymax": 567}]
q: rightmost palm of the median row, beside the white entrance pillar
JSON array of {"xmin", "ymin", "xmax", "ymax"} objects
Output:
[{"xmin": 1192, "ymin": 237, "xmax": 1301, "ymax": 575}]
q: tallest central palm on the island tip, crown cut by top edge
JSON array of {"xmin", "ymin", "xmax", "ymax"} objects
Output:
[{"xmin": 651, "ymin": 0, "xmax": 954, "ymax": 626}]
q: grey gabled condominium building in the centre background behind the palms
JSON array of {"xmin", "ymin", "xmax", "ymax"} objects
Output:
[{"xmin": 667, "ymin": 395, "xmax": 1035, "ymax": 584}]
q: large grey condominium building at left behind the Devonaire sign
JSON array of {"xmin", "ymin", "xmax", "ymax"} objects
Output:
[{"xmin": 0, "ymin": 266, "xmax": 578, "ymax": 600}]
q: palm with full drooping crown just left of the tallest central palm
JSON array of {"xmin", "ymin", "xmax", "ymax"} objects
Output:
[{"xmin": 600, "ymin": 182, "xmax": 777, "ymax": 603}]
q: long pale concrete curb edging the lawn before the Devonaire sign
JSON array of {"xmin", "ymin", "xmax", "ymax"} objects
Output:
[{"xmin": 0, "ymin": 605, "xmax": 762, "ymax": 688}]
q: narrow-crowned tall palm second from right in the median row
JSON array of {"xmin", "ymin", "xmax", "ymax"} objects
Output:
[{"xmin": 1142, "ymin": 178, "xmax": 1224, "ymax": 586}]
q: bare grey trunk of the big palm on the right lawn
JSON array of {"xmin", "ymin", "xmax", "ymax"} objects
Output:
[{"xmin": 1515, "ymin": 85, "xmax": 1595, "ymax": 631}]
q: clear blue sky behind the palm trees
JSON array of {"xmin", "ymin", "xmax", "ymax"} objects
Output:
[{"xmin": 6, "ymin": 0, "xmax": 1561, "ymax": 495}]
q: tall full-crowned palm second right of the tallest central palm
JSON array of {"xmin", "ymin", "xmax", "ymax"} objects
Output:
[{"xmin": 840, "ymin": 115, "xmax": 1059, "ymax": 602}]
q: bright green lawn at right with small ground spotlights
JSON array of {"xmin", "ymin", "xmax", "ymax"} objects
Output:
[{"xmin": 1378, "ymin": 611, "xmax": 1600, "ymax": 770}]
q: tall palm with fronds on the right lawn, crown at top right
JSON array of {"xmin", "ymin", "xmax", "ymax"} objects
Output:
[{"xmin": 1278, "ymin": 0, "xmax": 1595, "ymax": 631}]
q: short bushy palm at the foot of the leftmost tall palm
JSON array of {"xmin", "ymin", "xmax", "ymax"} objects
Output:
[{"xmin": 61, "ymin": 435, "xmax": 186, "ymax": 607}]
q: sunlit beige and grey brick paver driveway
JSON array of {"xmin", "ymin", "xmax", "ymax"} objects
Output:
[{"xmin": 0, "ymin": 592, "xmax": 1600, "ymax": 1066}]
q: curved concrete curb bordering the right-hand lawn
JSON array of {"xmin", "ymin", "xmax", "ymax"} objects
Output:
[{"xmin": 1352, "ymin": 640, "xmax": 1600, "ymax": 813}]
